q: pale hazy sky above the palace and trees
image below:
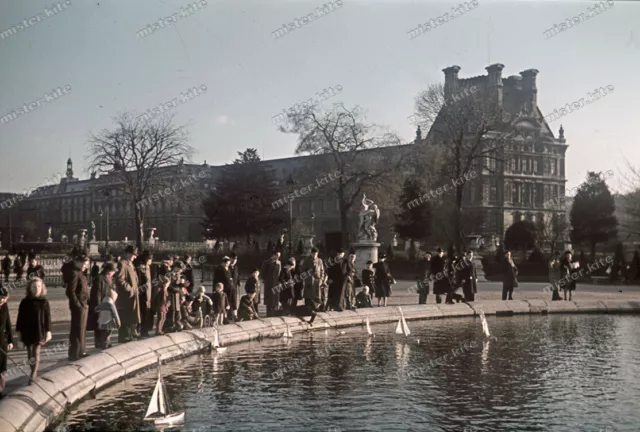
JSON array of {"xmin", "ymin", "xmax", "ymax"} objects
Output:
[{"xmin": 0, "ymin": 0, "xmax": 640, "ymax": 192}]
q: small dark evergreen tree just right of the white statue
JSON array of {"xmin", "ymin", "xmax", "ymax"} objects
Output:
[{"xmin": 394, "ymin": 177, "xmax": 432, "ymax": 241}]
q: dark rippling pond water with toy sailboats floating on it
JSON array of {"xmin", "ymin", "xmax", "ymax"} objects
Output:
[{"xmin": 53, "ymin": 315, "xmax": 640, "ymax": 432}]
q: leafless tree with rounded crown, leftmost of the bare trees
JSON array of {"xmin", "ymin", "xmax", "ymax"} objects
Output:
[{"xmin": 88, "ymin": 113, "xmax": 193, "ymax": 248}]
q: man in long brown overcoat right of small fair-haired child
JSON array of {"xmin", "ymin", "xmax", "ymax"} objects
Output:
[{"xmin": 116, "ymin": 246, "xmax": 140, "ymax": 343}]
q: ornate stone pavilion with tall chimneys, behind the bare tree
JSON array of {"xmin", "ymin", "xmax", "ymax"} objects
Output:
[{"xmin": 422, "ymin": 64, "xmax": 568, "ymax": 246}]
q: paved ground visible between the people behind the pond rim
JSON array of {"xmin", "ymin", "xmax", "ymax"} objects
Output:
[{"xmin": 2, "ymin": 281, "xmax": 640, "ymax": 391}]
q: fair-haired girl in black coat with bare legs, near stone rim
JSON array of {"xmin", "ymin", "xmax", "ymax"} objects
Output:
[{"xmin": 16, "ymin": 277, "xmax": 51, "ymax": 385}]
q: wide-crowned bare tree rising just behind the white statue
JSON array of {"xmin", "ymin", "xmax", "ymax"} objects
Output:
[{"xmin": 280, "ymin": 104, "xmax": 406, "ymax": 247}]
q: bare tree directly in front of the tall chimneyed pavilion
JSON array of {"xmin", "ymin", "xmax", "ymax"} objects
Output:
[{"xmin": 415, "ymin": 84, "xmax": 512, "ymax": 251}]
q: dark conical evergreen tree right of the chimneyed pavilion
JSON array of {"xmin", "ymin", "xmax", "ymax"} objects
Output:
[{"xmin": 570, "ymin": 172, "xmax": 618, "ymax": 261}]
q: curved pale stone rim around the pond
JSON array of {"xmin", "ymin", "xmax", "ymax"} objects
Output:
[{"xmin": 0, "ymin": 300, "xmax": 640, "ymax": 432}]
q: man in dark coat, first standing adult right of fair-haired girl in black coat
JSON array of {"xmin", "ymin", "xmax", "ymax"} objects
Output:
[{"xmin": 66, "ymin": 254, "xmax": 89, "ymax": 361}]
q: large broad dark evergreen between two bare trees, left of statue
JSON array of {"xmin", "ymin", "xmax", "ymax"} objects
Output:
[{"xmin": 203, "ymin": 162, "xmax": 285, "ymax": 243}]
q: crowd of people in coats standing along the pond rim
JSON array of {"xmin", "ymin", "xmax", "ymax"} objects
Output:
[{"xmin": 0, "ymin": 241, "xmax": 604, "ymax": 398}]
